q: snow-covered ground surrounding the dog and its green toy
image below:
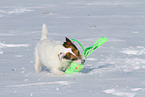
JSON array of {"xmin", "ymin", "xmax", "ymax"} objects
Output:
[{"xmin": 0, "ymin": 0, "xmax": 145, "ymax": 97}]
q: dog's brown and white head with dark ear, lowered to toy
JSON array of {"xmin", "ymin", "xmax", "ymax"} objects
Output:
[{"xmin": 60, "ymin": 37, "xmax": 85, "ymax": 64}]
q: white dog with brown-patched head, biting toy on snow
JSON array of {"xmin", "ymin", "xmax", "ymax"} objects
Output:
[{"xmin": 35, "ymin": 24, "xmax": 85, "ymax": 75}]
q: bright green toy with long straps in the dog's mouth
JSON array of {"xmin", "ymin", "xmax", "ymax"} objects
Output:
[{"xmin": 65, "ymin": 37, "xmax": 107, "ymax": 74}]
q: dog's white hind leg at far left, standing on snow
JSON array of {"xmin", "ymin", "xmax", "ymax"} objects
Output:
[{"xmin": 35, "ymin": 48, "xmax": 42, "ymax": 73}]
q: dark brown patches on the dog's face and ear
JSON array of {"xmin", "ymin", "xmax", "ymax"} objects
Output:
[{"xmin": 63, "ymin": 37, "xmax": 82, "ymax": 61}]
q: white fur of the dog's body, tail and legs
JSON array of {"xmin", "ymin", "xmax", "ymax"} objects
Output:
[{"xmin": 35, "ymin": 24, "xmax": 81, "ymax": 75}]
